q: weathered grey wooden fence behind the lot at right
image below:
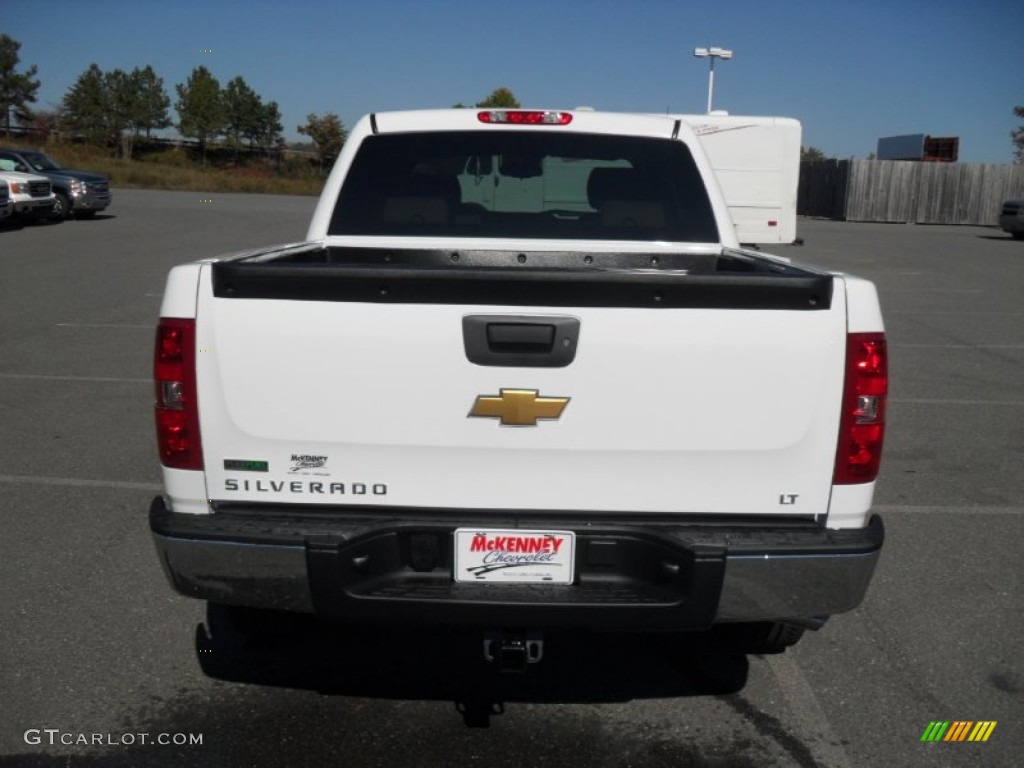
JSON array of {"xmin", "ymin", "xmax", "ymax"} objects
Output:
[{"xmin": 797, "ymin": 160, "xmax": 1024, "ymax": 225}]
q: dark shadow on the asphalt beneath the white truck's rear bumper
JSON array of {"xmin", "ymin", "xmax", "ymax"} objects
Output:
[{"xmin": 196, "ymin": 606, "xmax": 749, "ymax": 726}]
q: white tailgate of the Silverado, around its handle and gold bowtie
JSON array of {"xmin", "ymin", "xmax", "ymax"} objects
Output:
[{"xmin": 197, "ymin": 257, "xmax": 846, "ymax": 515}]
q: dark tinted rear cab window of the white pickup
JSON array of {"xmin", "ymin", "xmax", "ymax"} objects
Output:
[{"xmin": 328, "ymin": 130, "xmax": 719, "ymax": 243}]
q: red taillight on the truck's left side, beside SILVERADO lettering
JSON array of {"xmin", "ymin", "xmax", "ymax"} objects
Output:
[{"xmin": 153, "ymin": 317, "xmax": 203, "ymax": 469}]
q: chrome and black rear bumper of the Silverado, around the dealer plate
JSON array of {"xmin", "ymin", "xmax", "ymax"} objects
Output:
[{"xmin": 151, "ymin": 498, "xmax": 885, "ymax": 630}]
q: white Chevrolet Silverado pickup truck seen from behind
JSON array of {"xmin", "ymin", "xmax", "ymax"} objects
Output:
[{"xmin": 150, "ymin": 110, "xmax": 887, "ymax": 668}]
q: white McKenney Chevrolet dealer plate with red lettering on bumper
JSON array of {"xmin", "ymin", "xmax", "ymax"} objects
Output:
[{"xmin": 455, "ymin": 528, "xmax": 575, "ymax": 584}]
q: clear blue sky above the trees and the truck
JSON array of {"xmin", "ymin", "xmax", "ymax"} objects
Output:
[{"xmin": 0, "ymin": 0, "xmax": 1024, "ymax": 163}]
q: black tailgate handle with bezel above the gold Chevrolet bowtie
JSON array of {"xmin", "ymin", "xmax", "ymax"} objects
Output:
[{"xmin": 462, "ymin": 314, "xmax": 580, "ymax": 368}]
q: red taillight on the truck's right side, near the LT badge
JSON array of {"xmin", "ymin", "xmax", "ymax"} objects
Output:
[{"xmin": 833, "ymin": 333, "xmax": 889, "ymax": 485}]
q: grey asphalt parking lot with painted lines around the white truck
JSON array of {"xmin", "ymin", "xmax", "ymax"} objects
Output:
[{"xmin": 0, "ymin": 190, "xmax": 1024, "ymax": 768}]
